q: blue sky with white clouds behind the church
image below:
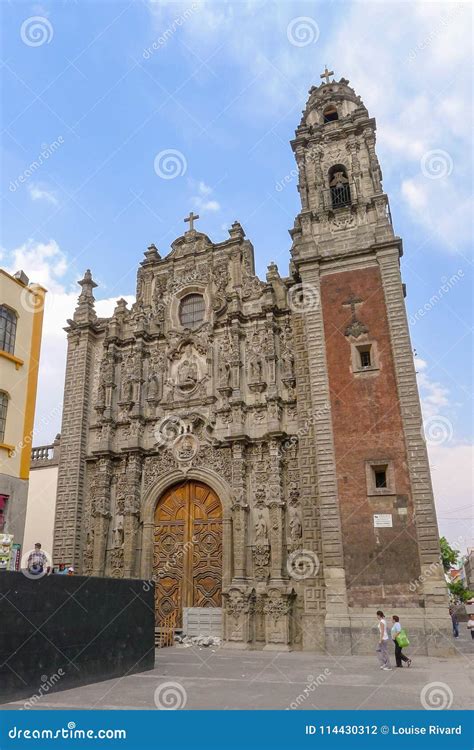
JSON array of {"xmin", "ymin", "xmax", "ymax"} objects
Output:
[{"xmin": 0, "ymin": 0, "xmax": 473, "ymax": 550}]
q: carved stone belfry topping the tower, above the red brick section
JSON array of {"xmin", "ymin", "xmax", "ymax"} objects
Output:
[{"xmin": 291, "ymin": 68, "xmax": 394, "ymax": 257}]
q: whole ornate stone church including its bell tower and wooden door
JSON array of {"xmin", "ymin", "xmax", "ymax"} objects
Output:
[{"xmin": 54, "ymin": 76, "xmax": 450, "ymax": 655}]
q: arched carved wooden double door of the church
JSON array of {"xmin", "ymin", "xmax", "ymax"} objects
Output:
[{"xmin": 153, "ymin": 481, "xmax": 222, "ymax": 627}]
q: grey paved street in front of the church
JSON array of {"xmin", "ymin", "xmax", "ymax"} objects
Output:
[{"xmin": 1, "ymin": 632, "xmax": 474, "ymax": 710}]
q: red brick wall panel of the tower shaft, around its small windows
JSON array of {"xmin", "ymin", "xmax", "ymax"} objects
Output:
[{"xmin": 321, "ymin": 265, "xmax": 420, "ymax": 607}]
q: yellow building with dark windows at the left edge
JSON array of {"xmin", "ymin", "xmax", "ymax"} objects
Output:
[{"xmin": 0, "ymin": 269, "xmax": 46, "ymax": 556}]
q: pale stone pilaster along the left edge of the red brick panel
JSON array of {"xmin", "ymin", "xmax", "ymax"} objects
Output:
[{"xmin": 293, "ymin": 268, "xmax": 350, "ymax": 653}]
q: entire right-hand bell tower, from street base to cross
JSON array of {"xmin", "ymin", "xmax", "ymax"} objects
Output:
[{"xmin": 290, "ymin": 68, "xmax": 449, "ymax": 653}]
